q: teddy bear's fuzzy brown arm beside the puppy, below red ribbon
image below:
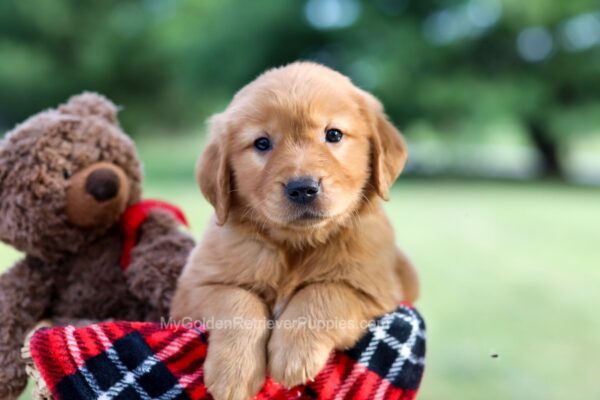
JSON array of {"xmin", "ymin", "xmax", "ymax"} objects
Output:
[{"xmin": 125, "ymin": 211, "xmax": 194, "ymax": 317}]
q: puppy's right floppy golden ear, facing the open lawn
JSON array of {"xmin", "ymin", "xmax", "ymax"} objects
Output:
[{"xmin": 359, "ymin": 90, "xmax": 408, "ymax": 200}]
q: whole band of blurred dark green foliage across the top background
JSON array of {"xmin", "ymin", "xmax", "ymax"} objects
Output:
[{"xmin": 0, "ymin": 0, "xmax": 600, "ymax": 174}]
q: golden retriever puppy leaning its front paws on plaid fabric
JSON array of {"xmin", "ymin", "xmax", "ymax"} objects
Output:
[{"xmin": 172, "ymin": 62, "xmax": 418, "ymax": 400}]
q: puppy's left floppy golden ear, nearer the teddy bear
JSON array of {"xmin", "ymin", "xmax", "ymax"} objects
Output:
[{"xmin": 196, "ymin": 115, "xmax": 231, "ymax": 225}]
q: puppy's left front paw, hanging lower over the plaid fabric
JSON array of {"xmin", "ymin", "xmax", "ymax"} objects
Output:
[{"xmin": 204, "ymin": 345, "xmax": 266, "ymax": 400}]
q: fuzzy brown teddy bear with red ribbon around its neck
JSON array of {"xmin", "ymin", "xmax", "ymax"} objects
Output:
[{"xmin": 0, "ymin": 93, "xmax": 194, "ymax": 399}]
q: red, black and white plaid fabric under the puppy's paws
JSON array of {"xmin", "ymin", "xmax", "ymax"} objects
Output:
[{"xmin": 30, "ymin": 305, "xmax": 425, "ymax": 400}]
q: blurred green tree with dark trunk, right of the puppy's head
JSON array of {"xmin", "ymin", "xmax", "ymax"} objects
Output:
[{"xmin": 318, "ymin": 0, "xmax": 600, "ymax": 176}]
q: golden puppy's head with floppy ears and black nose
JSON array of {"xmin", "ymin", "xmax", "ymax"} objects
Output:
[{"xmin": 198, "ymin": 63, "xmax": 406, "ymax": 238}]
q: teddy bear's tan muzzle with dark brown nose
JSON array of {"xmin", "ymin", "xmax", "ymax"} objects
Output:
[{"xmin": 67, "ymin": 162, "xmax": 129, "ymax": 227}]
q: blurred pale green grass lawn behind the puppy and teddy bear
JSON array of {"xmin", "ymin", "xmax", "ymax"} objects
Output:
[{"xmin": 8, "ymin": 178, "xmax": 600, "ymax": 400}]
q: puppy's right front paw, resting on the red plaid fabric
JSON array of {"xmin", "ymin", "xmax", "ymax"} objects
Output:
[{"xmin": 269, "ymin": 330, "xmax": 333, "ymax": 388}]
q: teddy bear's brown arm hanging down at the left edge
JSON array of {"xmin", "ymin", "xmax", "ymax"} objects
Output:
[{"xmin": 0, "ymin": 257, "xmax": 53, "ymax": 399}]
